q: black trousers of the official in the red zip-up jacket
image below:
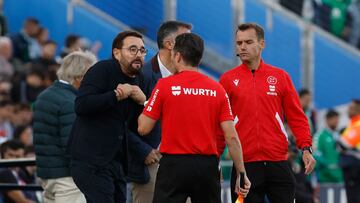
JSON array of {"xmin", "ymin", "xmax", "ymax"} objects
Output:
[{"xmin": 231, "ymin": 161, "xmax": 295, "ymax": 203}]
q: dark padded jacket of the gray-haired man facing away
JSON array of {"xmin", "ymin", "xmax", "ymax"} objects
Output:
[{"xmin": 33, "ymin": 81, "xmax": 77, "ymax": 179}]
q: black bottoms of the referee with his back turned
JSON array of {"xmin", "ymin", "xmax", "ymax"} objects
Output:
[{"xmin": 153, "ymin": 154, "xmax": 221, "ymax": 203}]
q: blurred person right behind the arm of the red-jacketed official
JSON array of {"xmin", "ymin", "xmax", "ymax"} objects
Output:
[{"xmin": 299, "ymin": 89, "xmax": 316, "ymax": 135}]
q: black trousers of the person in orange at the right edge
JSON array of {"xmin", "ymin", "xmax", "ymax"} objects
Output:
[{"xmin": 343, "ymin": 166, "xmax": 360, "ymax": 203}]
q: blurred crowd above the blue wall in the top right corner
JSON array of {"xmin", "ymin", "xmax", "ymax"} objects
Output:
[{"xmin": 279, "ymin": 0, "xmax": 360, "ymax": 49}]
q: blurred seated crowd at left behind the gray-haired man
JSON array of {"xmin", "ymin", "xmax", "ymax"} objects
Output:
[{"xmin": 0, "ymin": 16, "xmax": 101, "ymax": 203}]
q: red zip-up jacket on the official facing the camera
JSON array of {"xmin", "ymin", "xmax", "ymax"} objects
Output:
[{"xmin": 220, "ymin": 61, "xmax": 312, "ymax": 162}]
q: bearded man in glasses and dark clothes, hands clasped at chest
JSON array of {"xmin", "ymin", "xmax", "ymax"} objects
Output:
[{"xmin": 69, "ymin": 31, "xmax": 146, "ymax": 203}]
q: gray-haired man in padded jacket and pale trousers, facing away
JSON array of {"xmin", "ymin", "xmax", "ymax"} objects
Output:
[{"xmin": 34, "ymin": 51, "xmax": 96, "ymax": 203}]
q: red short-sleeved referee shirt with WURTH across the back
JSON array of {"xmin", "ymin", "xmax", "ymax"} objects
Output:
[{"xmin": 143, "ymin": 71, "xmax": 233, "ymax": 155}]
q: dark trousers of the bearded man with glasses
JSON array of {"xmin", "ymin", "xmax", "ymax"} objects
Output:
[{"xmin": 71, "ymin": 160, "xmax": 126, "ymax": 203}]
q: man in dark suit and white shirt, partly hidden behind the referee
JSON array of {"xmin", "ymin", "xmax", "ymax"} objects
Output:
[{"xmin": 128, "ymin": 21, "xmax": 192, "ymax": 203}]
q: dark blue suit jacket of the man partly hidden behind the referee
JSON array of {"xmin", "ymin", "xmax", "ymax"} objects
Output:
[{"xmin": 127, "ymin": 55, "xmax": 161, "ymax": 184}]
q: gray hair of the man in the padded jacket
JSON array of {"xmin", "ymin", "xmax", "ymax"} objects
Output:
[{"xmin": 56, "ymin": 51, "xmax": 97, "ymax": 84}]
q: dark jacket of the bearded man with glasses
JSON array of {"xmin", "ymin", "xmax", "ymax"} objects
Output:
[{"xmin": 69, "ymin": 59, "xmax": 143, "ymax": 173}]
